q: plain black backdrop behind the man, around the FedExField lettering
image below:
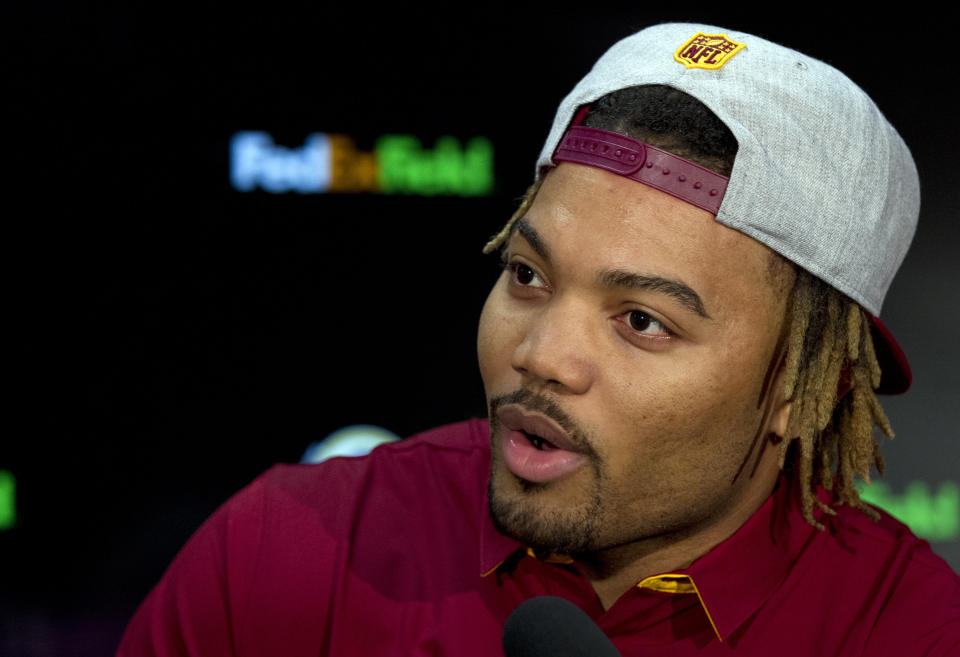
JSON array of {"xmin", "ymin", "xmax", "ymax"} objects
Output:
[{"xmin": 0, "ymin": 2, "xmax": 960, "ymax": 655}]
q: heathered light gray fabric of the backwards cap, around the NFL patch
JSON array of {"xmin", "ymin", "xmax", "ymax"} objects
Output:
[{"xmin": 537, "ymin": 24, "xmax": 920, "ymax": 315}]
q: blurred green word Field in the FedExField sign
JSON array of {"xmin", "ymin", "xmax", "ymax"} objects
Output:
[{"xmin": 374, "ymin": 135, "xmax": 493, "ymax": 196}]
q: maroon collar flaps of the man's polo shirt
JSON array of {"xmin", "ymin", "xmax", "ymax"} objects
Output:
[{"xmin": 480, "ymin": 468, "xmax": 824, "ymax": 640}]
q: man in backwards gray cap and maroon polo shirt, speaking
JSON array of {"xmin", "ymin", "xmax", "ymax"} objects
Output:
[{"xmin": 120, "ymin": 25, "xmax": 960, "ymax": 655}]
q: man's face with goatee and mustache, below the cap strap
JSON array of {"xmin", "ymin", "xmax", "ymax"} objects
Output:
[{"xmin": 478, "ymin": 163, "xmax": 787, "ymax": 553}]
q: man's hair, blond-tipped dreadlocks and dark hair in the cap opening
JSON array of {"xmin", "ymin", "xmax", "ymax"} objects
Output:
[{"xmin": 483, "ymin": 85, "xmax": 893, "ymax": 530}]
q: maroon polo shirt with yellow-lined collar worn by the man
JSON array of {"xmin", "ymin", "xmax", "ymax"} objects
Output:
[{"xmin": 118, "ymin": 420, "xmax": 960, "ymax": 657}]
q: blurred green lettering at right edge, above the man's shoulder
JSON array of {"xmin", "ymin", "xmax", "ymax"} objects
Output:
[{"xmin": 858, "ymin": 481, "xmax": 960, "ymax": 541}]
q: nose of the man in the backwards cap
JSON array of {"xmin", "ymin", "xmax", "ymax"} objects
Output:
[{"xmin": 511, "ymin": 299, "xmax": 595, "ymax": 394}]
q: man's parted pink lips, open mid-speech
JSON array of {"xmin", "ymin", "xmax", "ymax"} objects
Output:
[{"xmin": 496, "ymin": 404, "xmax": 589, "ymax": 483}]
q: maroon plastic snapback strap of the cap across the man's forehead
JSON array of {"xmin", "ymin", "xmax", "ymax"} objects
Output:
[{"xmin": 553, "ymin": 125, "xmax": 730, "ymax": 215}]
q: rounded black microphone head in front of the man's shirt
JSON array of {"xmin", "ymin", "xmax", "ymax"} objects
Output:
[{"xmin": 503, "ymin": 595, "xmax": 620, "ymax": 657}]
